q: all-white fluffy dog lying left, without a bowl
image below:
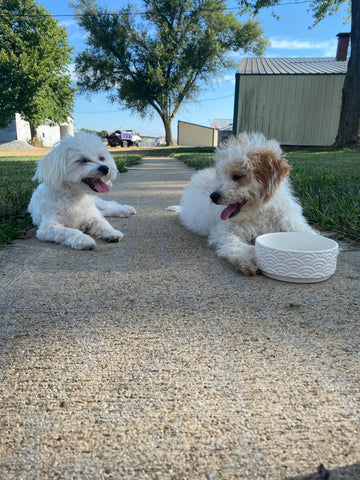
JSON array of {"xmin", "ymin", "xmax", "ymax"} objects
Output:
[{"xmin": 28, "ymin": 133, "xmax": 136, "ymax": 249}]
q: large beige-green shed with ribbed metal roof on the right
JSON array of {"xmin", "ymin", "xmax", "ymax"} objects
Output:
[{"xmin": 233, "ymin": 39, "xmax": 348, "ymax": 146}]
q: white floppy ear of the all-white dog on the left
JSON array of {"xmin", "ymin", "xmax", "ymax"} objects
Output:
[{"xmin": 33, "ymin": 143, "xmax": 66, "ymax": 187}]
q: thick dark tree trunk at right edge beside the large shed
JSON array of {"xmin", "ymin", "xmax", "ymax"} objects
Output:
[{"xmin": 334, "ymin": 1, "xmax": 360, "ymax": 148}]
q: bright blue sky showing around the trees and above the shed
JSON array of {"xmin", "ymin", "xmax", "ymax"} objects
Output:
[{"xmin": 39, "ymin": 0, "xmax": 350, "ymax": 138}]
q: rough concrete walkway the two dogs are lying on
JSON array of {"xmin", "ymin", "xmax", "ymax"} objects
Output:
[{"xmin": 0, "ymin": 158, "xmax": 360, "ymax": 480}]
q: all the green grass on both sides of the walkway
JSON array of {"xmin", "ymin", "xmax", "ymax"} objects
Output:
[{"xmin": 0, "ymin": 148, "xmax": 360, "ymax": 245}]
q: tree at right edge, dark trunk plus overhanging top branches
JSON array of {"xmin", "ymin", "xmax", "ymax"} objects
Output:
[{"xmin": 239, "ymin": 0, "xmax": 360, "ymax": 148}]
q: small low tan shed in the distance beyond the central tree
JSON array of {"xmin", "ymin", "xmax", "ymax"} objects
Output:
[{"xmin": 177, "ymin": 120, "xmax": 218, "ymax": 147}]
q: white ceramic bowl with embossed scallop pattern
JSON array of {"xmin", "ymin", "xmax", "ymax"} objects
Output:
[{"xmin": 255, "ymin": 232, "xmax": 339, "ymax": 283}]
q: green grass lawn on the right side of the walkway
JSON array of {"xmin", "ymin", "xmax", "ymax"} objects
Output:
[{"xmin": 176, "ymin": 151, "xmax": 360, "ymax": 242}]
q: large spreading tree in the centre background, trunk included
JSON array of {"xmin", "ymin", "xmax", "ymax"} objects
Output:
[{"xmin": 73, "ymin": 0, "xmax": 266, "ymax": 145}]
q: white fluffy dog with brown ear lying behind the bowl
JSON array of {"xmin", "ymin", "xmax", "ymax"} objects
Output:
[{"xmin": 168, "ymin": 133, "xmax": 315, "ymax": 275}]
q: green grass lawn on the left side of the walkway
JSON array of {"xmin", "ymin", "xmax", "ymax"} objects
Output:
[{"xmin": 0, "ymin": 153, "xmax": 141, "ymax": 246}]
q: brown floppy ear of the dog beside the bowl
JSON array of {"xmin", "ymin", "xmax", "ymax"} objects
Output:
[{"xmin": 247, "ymin": 145, "xmax": 291, "ymax": 202}]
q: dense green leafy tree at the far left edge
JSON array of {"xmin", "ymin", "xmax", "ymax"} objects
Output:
[{"xmin": 0, "ymin": 0, "xmax": 75, "ymax": 142}]
